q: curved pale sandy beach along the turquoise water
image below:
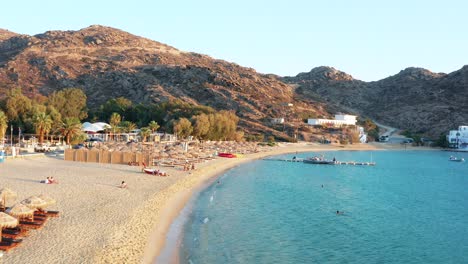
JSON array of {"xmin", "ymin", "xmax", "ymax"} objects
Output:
[{"xmin": 0, "ymin": 143, "xmax": 416, "ymax": 263}]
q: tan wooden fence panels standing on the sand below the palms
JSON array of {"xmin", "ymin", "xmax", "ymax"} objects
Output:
[{"xmin": 65, "ymin": 149, "xmax": 151, "ymax": 164}]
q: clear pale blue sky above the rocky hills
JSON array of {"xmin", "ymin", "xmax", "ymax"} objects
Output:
[{"xmin": 0, "ymin": 0, "xmax": 468, "ymax": 81}]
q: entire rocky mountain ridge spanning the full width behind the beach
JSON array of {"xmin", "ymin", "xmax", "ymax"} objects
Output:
[{"xmin": 0, "ymin": 25, "xmax": 468, "ymax": 136}]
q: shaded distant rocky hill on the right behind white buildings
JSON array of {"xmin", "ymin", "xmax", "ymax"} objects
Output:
[{"xmin": 283, "ymin": 66, "xmax": 468, "ymax": 137}]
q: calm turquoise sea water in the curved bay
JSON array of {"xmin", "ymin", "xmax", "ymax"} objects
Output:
[{"xmin": 179, "ymin": 151, "xmax": 468, "ymax": 264}]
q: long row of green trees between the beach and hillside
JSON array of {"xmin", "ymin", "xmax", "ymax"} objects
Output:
[{"xmin": 0, "ymin": 88, "xmax": 243, "ymax": 144}]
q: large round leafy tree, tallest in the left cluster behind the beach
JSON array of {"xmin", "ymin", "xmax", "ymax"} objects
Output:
[{"xmin": 48, "ymin": 88, "xmax": 88, "ymax": 120}]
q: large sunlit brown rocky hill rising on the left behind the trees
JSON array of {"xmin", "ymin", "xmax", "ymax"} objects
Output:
[{"xmin": 0, "ymin": 26, "xmax": 327, "ymax": 137}]
